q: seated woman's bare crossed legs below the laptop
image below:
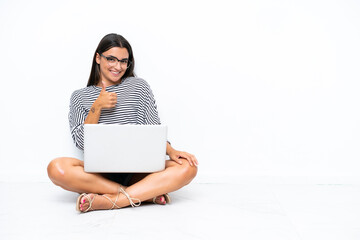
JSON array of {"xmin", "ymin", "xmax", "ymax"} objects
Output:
[{"xmin": 48, "ymin": 158, "xmax": 197, "ymax": 212}]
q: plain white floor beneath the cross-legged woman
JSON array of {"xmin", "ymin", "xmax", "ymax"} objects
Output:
[{"xmin": 0, "ymin": 182, "xmax": 360, "ymax": 240}]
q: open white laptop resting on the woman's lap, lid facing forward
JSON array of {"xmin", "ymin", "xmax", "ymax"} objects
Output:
[{"xmin": 84, "ymin": 124, "xmax": 167, "ymax": 173}]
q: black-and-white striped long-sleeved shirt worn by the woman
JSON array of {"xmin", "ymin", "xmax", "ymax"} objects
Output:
[{"xmin": 69, "ymin": 77, "xmax": 161, "ymax": 150}]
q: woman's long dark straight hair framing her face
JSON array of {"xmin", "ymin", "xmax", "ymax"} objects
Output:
[{"xmin": 87, "ymin": 33, "xmax": 135, "ymax": 86}]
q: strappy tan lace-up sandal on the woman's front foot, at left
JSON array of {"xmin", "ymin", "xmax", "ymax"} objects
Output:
[{"xmin": 76, "ymin": 187, "xmax": 141, "ymax": 213}]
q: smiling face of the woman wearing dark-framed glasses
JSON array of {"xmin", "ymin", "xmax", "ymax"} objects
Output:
[{"xmin": 96, "ymin": 47, "xmax": 129, "ymax": 86}]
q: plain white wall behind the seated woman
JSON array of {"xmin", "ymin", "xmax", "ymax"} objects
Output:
[{"xmin": 0, "ymin": 0, "xmax": 360, "ymax": 182}]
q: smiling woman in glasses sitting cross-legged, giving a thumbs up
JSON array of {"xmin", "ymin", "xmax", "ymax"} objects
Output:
[{"xmin": 47, "ymin": 34, "xmax": 198, "ymax": 212}]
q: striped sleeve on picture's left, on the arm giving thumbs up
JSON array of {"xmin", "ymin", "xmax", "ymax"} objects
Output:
[{"xmin": 69, "ymin": 91, "xmax": 87, "ymax": 150}]
